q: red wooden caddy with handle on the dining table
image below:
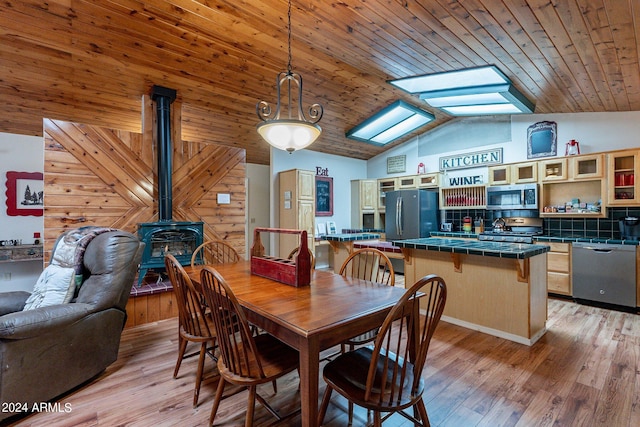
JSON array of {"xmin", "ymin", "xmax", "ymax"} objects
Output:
[{"xmin": 251, "ymin": 227, "xmax": 311, "ymax": 287}]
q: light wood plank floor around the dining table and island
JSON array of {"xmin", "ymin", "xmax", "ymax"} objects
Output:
[{"xmin": 5, "ymin": 299, "xmax": 640, "ymax": 427}]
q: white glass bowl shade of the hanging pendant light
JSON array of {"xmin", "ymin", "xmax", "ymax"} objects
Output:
[{"xmin": 257, "ymin": 119, "xmax": 322, "ymax": 152}]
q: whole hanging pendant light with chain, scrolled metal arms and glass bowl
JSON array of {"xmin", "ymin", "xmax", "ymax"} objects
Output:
[{"xmin": 256, "ymin": 0, "xmax": 323, "ymax": 153}]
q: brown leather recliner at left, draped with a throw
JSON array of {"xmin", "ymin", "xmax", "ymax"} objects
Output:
[{"xmin": 0, "ymin": 230, "xmax": 144, "ymax": 420}]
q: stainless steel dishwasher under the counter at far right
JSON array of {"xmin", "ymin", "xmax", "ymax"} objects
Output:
[{"xmin": 571, "ymin": 242, "xmax": 636, "ymax": 307}]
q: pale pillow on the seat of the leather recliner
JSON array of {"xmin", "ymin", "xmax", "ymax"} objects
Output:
[{"xmin": 23, "ymin": 264, "xmax": 76, "ymax": 311}]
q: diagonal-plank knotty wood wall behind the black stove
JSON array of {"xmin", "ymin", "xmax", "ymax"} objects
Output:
[{"xmin": 44, "ymin": 96, "xmax": 246, "ymax": 324}]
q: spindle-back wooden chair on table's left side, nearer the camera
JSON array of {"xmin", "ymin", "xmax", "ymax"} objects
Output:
[{"xmin": 200, "ymin": 267, "xmax": 299, "ymax": 426}]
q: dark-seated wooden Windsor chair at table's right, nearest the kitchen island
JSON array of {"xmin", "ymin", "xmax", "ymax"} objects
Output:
[{"xmin": 318, "ymin": 275, "xmax": 447, "ymax": 427}]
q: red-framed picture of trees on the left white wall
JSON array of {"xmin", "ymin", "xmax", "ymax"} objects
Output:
[{"xmin": 6, "ymin": 171, "xmax": 44, "ymax": 216}]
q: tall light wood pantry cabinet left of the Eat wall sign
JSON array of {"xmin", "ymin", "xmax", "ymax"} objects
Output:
[{"xmin": 278, "ymin": 169, "xmax": 316, "ymax": 258}]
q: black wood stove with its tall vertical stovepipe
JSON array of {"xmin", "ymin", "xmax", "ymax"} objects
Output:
[{"xmin": 138, "ymin": 86, "xmax": 204, "ymax": 286}]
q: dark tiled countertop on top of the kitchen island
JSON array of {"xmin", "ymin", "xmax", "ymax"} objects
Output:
[{"xmin": 393, "ymin": 237, "xmax": 549, "ymax": 259}]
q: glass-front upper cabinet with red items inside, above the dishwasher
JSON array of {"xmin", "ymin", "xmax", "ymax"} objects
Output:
[{"xmin": 607, "ymin": 150, "xmax": 640, "ymax": 206}]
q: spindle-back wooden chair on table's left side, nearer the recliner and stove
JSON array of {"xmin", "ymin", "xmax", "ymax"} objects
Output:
[{"xmin": 164, "ymin": 254, "xmax": 217, "ymax": 408}]
